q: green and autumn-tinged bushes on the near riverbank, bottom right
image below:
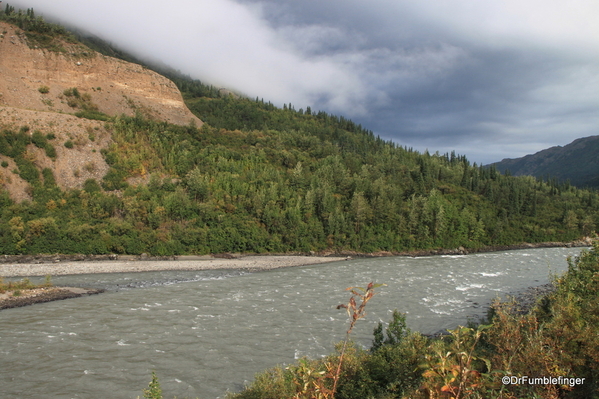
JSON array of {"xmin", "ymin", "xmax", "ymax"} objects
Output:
[{"xmin": 228, "ymin": 246, "xmax": 599, "ymax": 399}]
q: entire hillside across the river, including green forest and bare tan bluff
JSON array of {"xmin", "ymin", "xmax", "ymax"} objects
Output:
[{"xmin": 0, "ymin": 11, "xmax": 599, "ymax": 255}]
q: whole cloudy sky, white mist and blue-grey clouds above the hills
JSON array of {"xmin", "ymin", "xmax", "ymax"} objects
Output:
[{"xmin": 8, "ymin": 0, "xmax": 599, "ymax": 164}]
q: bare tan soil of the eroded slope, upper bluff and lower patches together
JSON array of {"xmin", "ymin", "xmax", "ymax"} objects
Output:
[{"xmin": 0, "ymin": 22, "xmax": 203, "ymax": 201}]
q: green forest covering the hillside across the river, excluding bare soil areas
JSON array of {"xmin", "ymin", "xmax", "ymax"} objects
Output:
[{"xmin": 0, "ymin": 10, "xmax": 599, "ymax": 256}]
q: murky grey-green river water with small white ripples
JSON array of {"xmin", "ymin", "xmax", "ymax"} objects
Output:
[{"xmin": 0, "ymin": 248, "xmax": 580, "ymax": 399}]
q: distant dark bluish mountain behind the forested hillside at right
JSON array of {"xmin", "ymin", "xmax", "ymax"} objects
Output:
[{"xmin": 492, "ymin": 136, "xmax": 599, "ymax": 188}]
